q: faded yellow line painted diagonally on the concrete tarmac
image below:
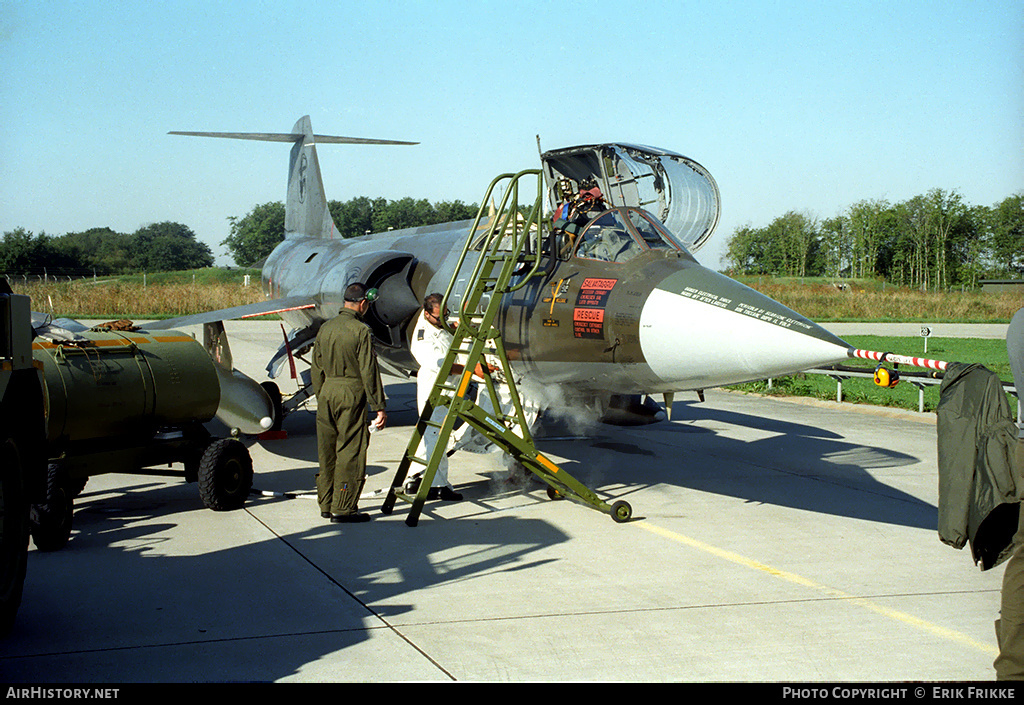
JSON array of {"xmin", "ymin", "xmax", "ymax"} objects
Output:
[{"xmin": 633, "ymin": 522, "xmax": 998, "ymax": 657}]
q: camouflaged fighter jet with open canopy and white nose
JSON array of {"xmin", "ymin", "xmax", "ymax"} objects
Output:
[{"xmin": 150, "ymin": 116, "xmax": 850, "ymax": 424}]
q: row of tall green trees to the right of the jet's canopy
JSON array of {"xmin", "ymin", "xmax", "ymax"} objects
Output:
[{"xmin": 725, "ymin": 189, "xmax": 1024, "ymax": 290}]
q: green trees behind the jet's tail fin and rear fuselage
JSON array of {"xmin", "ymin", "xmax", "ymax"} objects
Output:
[{"xmin": 221, "ymin": 196, "xmax": 479, "ymax": 266}]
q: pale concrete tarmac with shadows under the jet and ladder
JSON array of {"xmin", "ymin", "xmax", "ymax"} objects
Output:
[{"xmin": 0, "ymin": 323, "xmax": 1002, "ymax": 683}]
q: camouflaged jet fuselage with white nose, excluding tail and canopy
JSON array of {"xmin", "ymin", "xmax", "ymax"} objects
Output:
[{"xmin": 263, "ymin": 208, "xmax": 848, "ymax": 395}]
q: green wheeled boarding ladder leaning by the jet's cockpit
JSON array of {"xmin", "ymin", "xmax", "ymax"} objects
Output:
[{"xmin": 381, "ymin": 169, "xmax": 633, "ymax": 527}]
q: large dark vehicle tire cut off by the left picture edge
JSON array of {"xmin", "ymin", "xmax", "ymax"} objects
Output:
[{"xmin": 0, "ymin": 438, "xmax": 29, "ymax": 636}]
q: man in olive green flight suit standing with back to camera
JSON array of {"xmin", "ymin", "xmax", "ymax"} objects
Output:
[{"xmin": 310, "ymin": 283, "xmax": 387, "ymax": 523}]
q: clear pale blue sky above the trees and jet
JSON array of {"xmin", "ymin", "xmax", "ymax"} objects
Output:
[{"xmin": 0, "ymin": 0, "xmax": 1024, "ymax": 267}]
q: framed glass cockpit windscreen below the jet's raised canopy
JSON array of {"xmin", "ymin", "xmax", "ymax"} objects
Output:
[{"xmin": 569, "ymin": 208, "xmax": 692, "ymax": 263}]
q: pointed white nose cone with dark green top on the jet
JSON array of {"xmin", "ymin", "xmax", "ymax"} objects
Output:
[{"xmin": 640, "ymin": 266, "xmax": 850, "ymax": 390}]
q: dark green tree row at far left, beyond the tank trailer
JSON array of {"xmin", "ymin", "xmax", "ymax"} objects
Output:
[{"xmin": 0, "ymin": 222, "xmax": 213, "ymax": 276}]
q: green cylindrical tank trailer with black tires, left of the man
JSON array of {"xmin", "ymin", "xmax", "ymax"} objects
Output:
[{"xmin": 27, "ymin": 320, "xmax": 275, "ymax": 550}]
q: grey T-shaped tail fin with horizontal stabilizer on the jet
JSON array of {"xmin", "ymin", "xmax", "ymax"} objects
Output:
[{"xmin": 170, "ymin": 115, "xmax": 419, "ymax": 238}]
